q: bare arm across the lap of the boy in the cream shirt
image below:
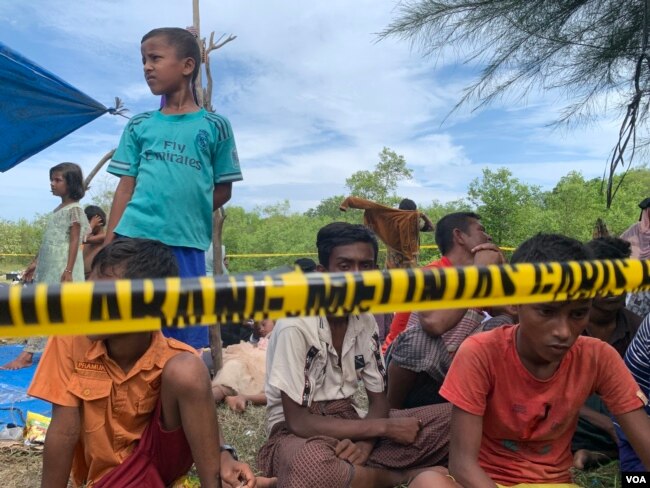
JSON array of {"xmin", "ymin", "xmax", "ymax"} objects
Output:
[{"xmin": 282, "ymin": 392, "xmax": 420, "ymax": 444}]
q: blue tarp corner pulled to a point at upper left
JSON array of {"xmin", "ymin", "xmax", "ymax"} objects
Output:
[{"xmin": 0, "ymin": 43, "xmax": 108, "ymax": 172}]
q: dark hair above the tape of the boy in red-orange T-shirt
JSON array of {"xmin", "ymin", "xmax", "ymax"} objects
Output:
[{"xmin": 510, "ymin": 233, "xmax": 593, "ymax": 264}]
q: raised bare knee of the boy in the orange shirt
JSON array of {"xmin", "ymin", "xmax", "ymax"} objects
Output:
[{"xmin": 161, "ymin": 352, "xmax": 212, "ymax": 395}]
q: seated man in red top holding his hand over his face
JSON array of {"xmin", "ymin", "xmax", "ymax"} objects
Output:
[{"xmin": 382, "ymin": 212, "xmax": 505, "ymax": 353}]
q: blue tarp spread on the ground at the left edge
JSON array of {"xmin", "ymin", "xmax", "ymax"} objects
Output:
[{"xmin": 0, "ymin": 345, "xmax": 52, "ymax": 429}]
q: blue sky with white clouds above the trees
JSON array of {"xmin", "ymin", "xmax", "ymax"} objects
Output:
[{"xmin": 0, "ymin": 0, "xmax": 617, "ymax": 220}]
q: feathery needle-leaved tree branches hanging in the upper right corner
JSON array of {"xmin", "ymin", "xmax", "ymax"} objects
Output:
[{"xmin": 381, "ymin": 0, "xmax": 650, "ymax": 207}]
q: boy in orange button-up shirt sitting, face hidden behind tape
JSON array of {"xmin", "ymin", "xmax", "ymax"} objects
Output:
[{"xmin": 28, "ymin": 239, "xmax": 260, "ymax": 488}]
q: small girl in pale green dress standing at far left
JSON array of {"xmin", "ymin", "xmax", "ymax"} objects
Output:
[{"xmin": 1, "ymin": 163, "xmax": 88, "ymax": 369}]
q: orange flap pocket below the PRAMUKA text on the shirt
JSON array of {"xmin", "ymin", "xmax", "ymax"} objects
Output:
[{"xmin": 68, "ymin": 373, "xmax": 113, "ymax": 432}]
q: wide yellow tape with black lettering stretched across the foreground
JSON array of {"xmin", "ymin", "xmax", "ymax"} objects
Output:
[{"xmin": 0, "ymin": 260, "xmax": 650, "ymax": 337}]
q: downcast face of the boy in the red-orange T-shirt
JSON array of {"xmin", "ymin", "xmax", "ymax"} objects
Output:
[{"xmin": 517, "ymin": 300, "xmax": 591, "ymax": 366}]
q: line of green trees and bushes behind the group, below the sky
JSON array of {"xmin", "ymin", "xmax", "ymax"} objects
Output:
[{"xmin": 0, "ymin": 154, "xmax": 650, "ymax": 273}]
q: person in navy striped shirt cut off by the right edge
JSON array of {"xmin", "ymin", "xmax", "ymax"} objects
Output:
[{"xmin": 615, "ymin": 314, "xmax": 650, "ymax": 471}]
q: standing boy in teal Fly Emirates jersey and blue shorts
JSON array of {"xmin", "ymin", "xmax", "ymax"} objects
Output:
[{"xmin": 105, "ymin": 27, "xmax": 242, "ymax": 348}]
